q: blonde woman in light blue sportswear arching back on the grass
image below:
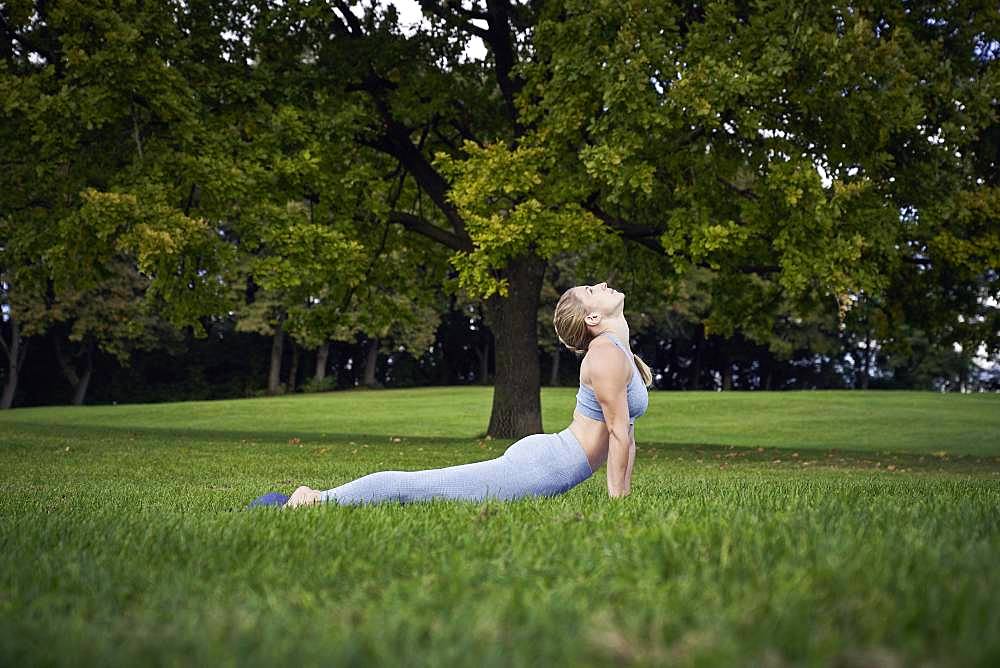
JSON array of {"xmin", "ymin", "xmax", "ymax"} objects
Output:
[{"xmin": 250, "ymin": 283, "xmax": 652, "ymax": 508}]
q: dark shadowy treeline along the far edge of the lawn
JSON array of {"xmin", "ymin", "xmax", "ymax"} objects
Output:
[{"xmin": 7, "ymin": 296, "xmax": 1000, "ymax": 406}]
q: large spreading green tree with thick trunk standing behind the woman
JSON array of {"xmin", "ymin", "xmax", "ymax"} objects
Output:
[{"xmin": 0, "ymin": 0, "xmax": 1000, "ymax": 422}]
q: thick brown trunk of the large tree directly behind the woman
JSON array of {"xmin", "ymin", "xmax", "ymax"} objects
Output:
[{"xmin": 485, "ymin": 255, "xmax": 545, "ymax": 438}]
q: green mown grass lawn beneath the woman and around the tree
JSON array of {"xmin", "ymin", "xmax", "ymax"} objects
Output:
[{"xmin": 0, "ymin": 387, "xmax": 1000, "ymax": 666}]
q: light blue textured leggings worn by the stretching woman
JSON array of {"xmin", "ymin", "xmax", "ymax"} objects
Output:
[{"xmin": 320, "ymin": 427, "xmax": 594, "ymax": 506}]
